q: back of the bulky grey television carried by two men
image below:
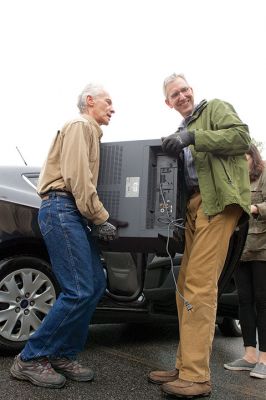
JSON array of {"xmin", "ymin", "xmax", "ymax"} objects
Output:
[{"xmin": 97, "ymin": 139, "xmax": 182, "ymax": 253}]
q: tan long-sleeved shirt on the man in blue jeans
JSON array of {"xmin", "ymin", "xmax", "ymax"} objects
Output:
[{"xmin": 37, "ymin": 114, "xmax": 109, "ymax": 225}]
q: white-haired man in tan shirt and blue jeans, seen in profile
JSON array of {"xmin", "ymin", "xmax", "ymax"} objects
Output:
[{"xmin": 11, "ymin": 84, "xmax": 116, "ymax": 388}]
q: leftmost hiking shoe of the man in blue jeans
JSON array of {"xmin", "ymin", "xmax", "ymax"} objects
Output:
[{"xmin": 10, "ymin": 355, "xmax": 66, "ymax": 388}]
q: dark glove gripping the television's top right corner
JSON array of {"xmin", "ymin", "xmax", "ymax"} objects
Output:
[{"xmin": 162, "ymin": 128, "xmax": 195, "ymax": 157}]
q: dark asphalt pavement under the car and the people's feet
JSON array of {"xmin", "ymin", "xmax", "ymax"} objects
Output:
[{"xmin": 0, "ymin": 325, "xmax": 266, "ymax": 400}]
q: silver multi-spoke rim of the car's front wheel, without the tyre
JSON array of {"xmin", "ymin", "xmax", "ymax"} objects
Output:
[{"xmin": 0, "ymin": 268, "xmax": 56, "ymax": 342}]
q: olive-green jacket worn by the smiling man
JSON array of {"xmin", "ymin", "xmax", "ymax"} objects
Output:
[{"xmin": 187, "ymin": 99, "xmax": 251, "ymax": 216}]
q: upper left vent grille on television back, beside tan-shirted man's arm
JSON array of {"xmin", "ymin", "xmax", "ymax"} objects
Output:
[{"xmin": 98, "ymin": 145, "xmax": 123, "ymax": 185}]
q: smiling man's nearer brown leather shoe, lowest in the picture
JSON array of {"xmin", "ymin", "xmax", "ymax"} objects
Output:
[{"xmin": 162, "ymin": 379, "xmax": 211, "ymax": 399}]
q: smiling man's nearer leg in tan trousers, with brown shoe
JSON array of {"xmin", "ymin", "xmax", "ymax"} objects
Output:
[{"xmin": 162, "ymin": 205, "xmax": 242, "ymax": 397}]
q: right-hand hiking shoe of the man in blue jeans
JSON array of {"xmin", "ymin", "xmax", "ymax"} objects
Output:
[{"xmin": 50, "ymin": 357, "xmax": 94, "ymax": 382}]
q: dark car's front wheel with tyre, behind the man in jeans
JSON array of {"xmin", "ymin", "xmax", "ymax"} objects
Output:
[{"xmin": 0, "ymin": 255, "xmax": 59, "ymax": 353}]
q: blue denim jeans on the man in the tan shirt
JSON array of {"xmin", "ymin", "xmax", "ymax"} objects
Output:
[{"xmin": 21, "ymin": 193, "xmax": 106, "ymax": 361}]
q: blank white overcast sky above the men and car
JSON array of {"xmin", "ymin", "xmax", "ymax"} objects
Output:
[{"xmin": 0, "ymin": 0, "xmax": 266, "ymax": 165}]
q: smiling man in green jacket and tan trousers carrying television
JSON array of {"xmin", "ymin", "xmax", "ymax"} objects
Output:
[{"xmin": 149, "ymin": 74, "xmax": 250, "ymax": 398}]
